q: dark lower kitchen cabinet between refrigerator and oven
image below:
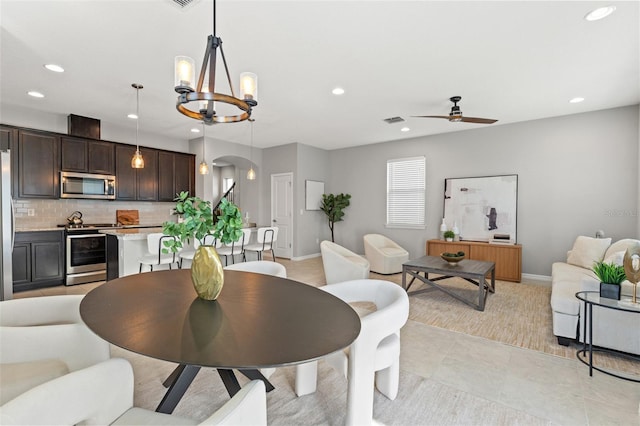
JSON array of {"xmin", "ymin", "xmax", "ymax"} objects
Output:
[{"xmin": 12, "ymin": 231, "xmax": 64, "ymax": 292}]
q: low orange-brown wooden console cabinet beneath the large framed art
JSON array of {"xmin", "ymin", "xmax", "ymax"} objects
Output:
[{"xmin": 426, "ymin": 240, "xmax": 522, "ymax": 282}]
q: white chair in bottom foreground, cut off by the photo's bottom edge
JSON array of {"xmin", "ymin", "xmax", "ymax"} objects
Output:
[{"xmin": 0, "ymin": 358, "xmax": 267, "ymax": 425}]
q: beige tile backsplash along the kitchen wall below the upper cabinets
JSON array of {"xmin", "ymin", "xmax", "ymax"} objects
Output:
[{"xmin": 14, "ymin": 199, "xmax": 176, "ymax": 229}]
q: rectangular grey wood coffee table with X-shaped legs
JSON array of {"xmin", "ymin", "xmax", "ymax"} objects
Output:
[{"xmin": 402, "ymin": 256, "xmax": 496, "ymax": 311}]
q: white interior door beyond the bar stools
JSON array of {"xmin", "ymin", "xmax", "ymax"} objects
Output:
[{"xmin": 271, "ymin": 173, "xmax": 293, "ymax": 259}]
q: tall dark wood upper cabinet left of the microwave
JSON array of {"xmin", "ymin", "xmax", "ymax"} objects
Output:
[{"xmin": 11, "ymin": 130, "xmax": 60, "ymax": 198}]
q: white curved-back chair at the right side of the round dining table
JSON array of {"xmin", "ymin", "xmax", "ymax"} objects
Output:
[{"xmin": 295, "ymin": 279, "xmax": 409, "ymax": 425}]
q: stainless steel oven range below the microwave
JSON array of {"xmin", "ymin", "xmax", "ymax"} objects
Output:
[{"xmin": 65, "ymin": 227, "xmax": 107, "ymax": 285}]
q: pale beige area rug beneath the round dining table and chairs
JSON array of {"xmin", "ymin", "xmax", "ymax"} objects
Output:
[{"xmin": 113, "ymin": 347, "xmax": 547, "ymax": 425}]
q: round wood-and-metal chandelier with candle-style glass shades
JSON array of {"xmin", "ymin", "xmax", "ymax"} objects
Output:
[{"xmin": 174, "ymin": 0, "xmax": 258, "ymax": 124}]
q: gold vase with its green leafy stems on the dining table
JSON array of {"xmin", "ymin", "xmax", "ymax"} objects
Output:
[{"xmin": 162, "ymin": 191, "xmax": 242, "ymax": 300}]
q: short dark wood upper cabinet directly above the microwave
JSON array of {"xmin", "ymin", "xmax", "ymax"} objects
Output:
[{"xmin": 61, "ymin": 137, "xmax": 115, "ymax": 175}]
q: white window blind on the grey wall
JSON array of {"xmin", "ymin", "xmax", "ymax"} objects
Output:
[{"xmin": 387, "ymin": 157, "xmax": 426, "ymax": 228}]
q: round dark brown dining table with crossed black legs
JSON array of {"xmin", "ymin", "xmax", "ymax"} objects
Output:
[{"xmin": 80, "ymin": 269, "xmax": 360, "ymax": 413}]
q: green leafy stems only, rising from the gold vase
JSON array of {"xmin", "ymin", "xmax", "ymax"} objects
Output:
[{"xmin": 162, "ymin": 191, "xmax": 242, "ymax": 253}]
